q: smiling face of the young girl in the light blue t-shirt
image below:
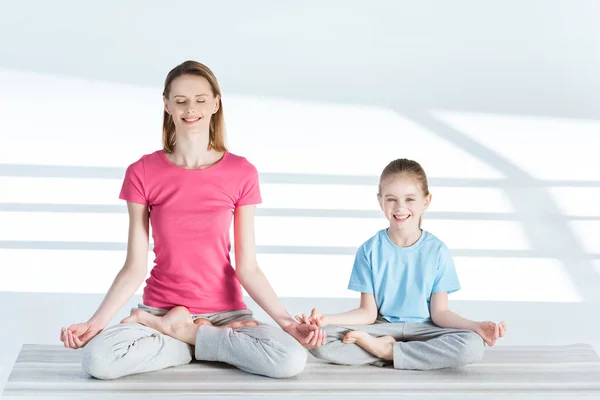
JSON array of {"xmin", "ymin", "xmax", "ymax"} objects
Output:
[{"xmin": 377, "ymin": 174, "xmax": 431, "ymax": 233}]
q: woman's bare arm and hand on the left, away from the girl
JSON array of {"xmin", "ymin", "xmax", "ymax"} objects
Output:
[{"xmin": 60, "ymin": 202, "xmax": 149, "ymax": 349}]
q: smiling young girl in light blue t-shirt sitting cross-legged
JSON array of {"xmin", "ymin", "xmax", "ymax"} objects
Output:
[{"xmin": 296, "ymin": 159, "xmax": 506, "ymax": 370}]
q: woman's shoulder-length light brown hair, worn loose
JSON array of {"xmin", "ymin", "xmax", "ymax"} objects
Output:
[{"xmin": 162, "ymin": 61, "xmax": 227, "ymax": 153}]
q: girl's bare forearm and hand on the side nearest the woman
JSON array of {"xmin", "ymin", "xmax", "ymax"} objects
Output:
[{"xmin": 296, "ymin": 293, "xmax": 377, "ymax": 327}]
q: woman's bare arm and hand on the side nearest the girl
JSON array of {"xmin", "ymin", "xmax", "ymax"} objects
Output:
[{"xmin": 233, "ymin": 205, "xmax": 326, "ymax": 348}]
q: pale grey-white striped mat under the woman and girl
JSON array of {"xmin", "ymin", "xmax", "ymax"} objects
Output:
[{"xmin": 4, "ymin": 344, "xmax": 600, "ymax": 398}]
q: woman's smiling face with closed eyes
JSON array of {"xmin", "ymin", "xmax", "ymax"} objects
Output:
[{"xmin": 163, "ymin": 75, "xmax": 219, "ymax": 134}]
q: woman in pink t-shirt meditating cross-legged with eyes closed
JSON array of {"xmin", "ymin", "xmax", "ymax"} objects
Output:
[{"xmin": 61, "ymin": 61, "xmax": 325, "ymax": 379}]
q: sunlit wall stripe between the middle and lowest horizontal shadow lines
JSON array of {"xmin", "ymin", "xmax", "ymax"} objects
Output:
[{"xmin": 0, "ymin": 212, "xmax": 530, "ymax": 250}]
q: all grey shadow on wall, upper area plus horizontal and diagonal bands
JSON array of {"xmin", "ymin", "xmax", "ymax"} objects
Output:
[{"xmin": 0, "ymin": 0, "xmax": 600, "ymax": 301}]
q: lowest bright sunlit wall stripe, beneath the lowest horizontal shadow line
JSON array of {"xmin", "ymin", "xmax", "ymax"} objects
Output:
[{"xmin": 0, "ymin": 249, "xmax": 580, "ymax": 302}]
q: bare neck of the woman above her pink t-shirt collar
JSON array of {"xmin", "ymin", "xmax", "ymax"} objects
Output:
[{"xmin": 169, "ymin": 132, "xmax": 223, "ymax": 169}]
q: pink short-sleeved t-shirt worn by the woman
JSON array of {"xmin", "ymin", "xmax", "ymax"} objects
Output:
[{"xmin": 119, "ymin": 150, "xmax": 261, "ymax": 314}]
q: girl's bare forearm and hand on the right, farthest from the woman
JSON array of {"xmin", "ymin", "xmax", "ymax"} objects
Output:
[{"xmin": 430, "ymin": 292, "xmax": 506, "ymax": 346}]
